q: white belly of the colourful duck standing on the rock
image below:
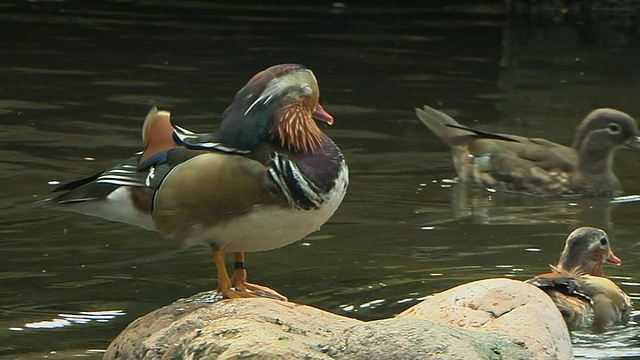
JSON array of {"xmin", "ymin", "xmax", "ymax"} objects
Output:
[{"xmin": 185, "ymin": 166, "xmax": 349, "ymax": 252}]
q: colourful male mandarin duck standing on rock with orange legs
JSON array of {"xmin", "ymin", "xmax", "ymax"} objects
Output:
[{"xmin": 45, "ymin": 64, "xmax": 348, "ymax": 301}]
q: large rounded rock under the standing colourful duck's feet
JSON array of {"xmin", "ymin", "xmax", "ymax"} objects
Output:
[{"xmin": 103, "ymin": 292, "xmax": 361, "ymax": 360}]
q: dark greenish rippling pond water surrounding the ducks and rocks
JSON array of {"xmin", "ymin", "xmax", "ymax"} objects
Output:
[{"xmin": 0, "ymin": 0, "xmax": 640, "ymax": 359}]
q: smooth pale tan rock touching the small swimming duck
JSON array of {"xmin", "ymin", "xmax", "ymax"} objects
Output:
[{"xmin": 398, "ymin": 279, "xmax": 573, "ymax": 359}]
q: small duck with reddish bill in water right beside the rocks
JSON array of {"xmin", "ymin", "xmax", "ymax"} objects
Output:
[{"xmin": 527, "ymin": 227, "xmax": 632, "ymax": 331}]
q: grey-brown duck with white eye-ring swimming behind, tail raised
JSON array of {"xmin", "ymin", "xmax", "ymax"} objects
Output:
[{"xmin": 416, "ymin": 106, "xmax": 640, "ymax": 196}]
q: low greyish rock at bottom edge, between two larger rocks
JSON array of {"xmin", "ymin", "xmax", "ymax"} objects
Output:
[{"xmin": 324, "ymin": 317, "xmax": 533, "ymax": 360}]
